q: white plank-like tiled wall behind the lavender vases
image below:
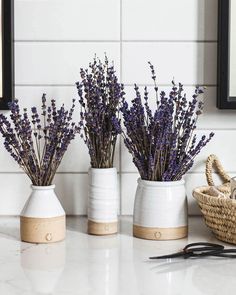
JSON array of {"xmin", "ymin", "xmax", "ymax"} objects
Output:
[{"xmin": 0, "ymin": 0, "xmax": 236, "ymax": 215}]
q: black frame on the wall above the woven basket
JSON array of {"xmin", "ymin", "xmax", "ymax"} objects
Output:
[{"xmin": 217, "ymin": 0, "xmax": 236, "ymax": 109}]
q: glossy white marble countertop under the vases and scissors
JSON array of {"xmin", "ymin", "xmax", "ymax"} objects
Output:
[{"xmin": 0, "ymin": 217, "xmax": 236, "ymax": 295}]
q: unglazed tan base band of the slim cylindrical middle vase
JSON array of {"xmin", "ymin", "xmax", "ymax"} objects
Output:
[{"xmin": 88, "ymin": 220, "xmax": 118, "ymax": 236}]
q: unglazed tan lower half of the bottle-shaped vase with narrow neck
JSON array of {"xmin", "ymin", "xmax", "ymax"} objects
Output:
[{"xmin": 20, "ymin": 215, "xmax": 66, "ymax": 244}]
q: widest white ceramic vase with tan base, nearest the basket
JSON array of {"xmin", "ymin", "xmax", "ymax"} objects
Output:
[{"xmin": 133, "ymin": 178, "xmax": 188, "ymax": 240}]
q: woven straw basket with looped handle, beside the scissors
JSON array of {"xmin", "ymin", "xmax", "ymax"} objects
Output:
[{"xmin": 193, "ymin": 155, "xmax": 236, "ymax": 244}]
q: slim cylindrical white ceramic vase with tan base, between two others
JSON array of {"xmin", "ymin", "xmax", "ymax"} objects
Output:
[{"xmin": 88, "ymin": 168, "xmax": 118, "ymax": 235}]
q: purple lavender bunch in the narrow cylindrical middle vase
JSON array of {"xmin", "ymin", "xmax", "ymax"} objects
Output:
[{"xmin": 76, "ymin": 57, "xmax": 124, "ymax": 168}]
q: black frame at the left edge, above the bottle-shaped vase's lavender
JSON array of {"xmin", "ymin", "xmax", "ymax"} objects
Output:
[{"xmin": 0, "ymin": 0, "xmax": 14, "ymax": 110}]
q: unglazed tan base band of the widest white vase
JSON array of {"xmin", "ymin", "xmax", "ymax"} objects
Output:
[{"xmin": 133, "ymin": 224, "xmax": 188, "ymax": 241}]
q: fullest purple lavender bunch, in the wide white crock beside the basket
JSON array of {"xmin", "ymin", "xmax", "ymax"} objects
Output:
[{"xmin": 114, "ymin": 63, "xmax": 214, "ymax": 181}]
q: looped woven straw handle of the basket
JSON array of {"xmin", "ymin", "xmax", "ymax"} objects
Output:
[{"xmin": 205, "ymin": 155, "xmax": 230, "ymax": 186}]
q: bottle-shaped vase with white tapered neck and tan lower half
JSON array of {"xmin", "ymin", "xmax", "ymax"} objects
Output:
[{"xmin": 20, "ymin": 185, "xmax": 66, "ymax": 243}]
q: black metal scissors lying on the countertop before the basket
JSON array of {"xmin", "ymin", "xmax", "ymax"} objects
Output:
[{"xmin": 149, "ymin": 242, "xmax": 236, "ymax": 259}]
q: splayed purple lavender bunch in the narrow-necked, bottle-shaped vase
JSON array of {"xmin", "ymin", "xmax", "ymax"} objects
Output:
[{"xmin": 0, "ymin": 94, "xmax": 79, "ymax": 186}]
